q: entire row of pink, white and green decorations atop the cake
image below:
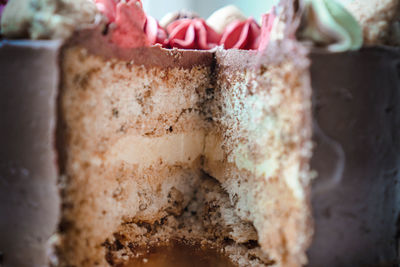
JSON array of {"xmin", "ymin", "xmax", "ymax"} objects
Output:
[{"xmin": 0, "ymin": 0, "xmax": 394, "ymax": 52}]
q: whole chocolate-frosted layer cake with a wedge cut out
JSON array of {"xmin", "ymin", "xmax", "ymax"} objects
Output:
[{"xmin": 0, "ymin": 0, "xmax": 399, "ymax": 266}]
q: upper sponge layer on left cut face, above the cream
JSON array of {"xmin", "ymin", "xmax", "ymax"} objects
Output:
[{"xmin": 63, "ymin": 46, "xmax": 211, "ymax": 137}]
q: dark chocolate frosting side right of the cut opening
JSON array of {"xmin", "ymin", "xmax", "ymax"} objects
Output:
[{"xmin": 309, "ymin": 47, "xmax": 400, "ymax": 267}]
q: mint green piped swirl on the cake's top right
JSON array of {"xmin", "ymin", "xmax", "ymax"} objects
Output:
[{"xmin": 300, "ymin": 0, "xmax": 363, "ymax": 52}]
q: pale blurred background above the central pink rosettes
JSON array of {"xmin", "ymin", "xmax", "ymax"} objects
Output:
[{"xmin": 142, "ymin": 0, "xmax": 278, "ymax": 20}]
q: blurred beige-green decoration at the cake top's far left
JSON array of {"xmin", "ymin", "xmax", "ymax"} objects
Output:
[{"xmin": 1, "ymin": 0, "xmax": 99, "ymax": 39}]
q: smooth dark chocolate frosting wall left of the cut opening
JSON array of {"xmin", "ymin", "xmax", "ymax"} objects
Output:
[{"xmin": 0, "ymin": 41, "xmax": 61, "ymax": 267}]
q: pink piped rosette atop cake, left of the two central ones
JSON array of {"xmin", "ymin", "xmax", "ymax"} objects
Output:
[{"xmin": 167, "ymin": 18, "xmax": 221, "ymax": 50}]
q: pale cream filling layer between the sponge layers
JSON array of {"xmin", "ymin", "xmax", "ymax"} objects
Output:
[{"xmin": 105, "ymin": 130, "xmax": 303, "ymax": 198}]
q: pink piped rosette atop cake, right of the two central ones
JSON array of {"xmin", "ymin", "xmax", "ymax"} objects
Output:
[{"xmin": 220, "ymin": 17, "xmax": 261, "ymax": 49}]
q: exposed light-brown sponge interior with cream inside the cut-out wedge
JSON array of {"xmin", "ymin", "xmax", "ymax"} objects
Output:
[{"xmin": 58, "ymin": 38, "xmax": 310, "ymax": 266}]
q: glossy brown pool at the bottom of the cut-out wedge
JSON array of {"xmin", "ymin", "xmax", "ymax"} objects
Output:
[{"xmin": 123, "ymin": 243, "xmax": 236, "ymax": 267}]
